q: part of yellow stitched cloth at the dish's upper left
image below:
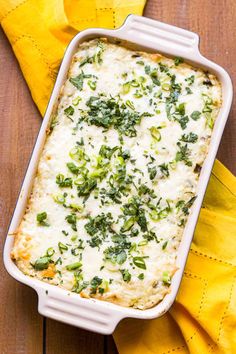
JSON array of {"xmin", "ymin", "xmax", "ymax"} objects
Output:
[{"xmin": 0, "ymin": 0, "xmax": 145, "ymax": 115}]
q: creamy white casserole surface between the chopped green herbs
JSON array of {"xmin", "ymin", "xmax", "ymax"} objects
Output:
[{"xmin": 12, "ymin": 40, "xmax": 221, "ymax": 309}]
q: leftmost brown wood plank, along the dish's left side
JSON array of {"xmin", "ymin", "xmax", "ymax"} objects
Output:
[{"xmin": 0, "ymin": 31, "xmax": 43, "ymax": 354}]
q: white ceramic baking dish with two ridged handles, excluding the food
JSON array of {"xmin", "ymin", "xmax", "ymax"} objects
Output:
[{"xmin": 4, "ymin": 15, "xmax": 233, "ymax": 334}]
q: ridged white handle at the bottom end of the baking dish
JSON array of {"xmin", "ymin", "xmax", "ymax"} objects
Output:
[{"xmin": 35, "ymin": 287, "xmax": 125, "ymax": 335}]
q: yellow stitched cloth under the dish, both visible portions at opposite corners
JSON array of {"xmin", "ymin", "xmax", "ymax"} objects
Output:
[{"xmin": 0, "ymin": 0, "xmax": 236, "ymax": 354}]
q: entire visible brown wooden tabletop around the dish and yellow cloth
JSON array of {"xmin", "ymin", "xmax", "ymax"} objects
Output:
[{"xmin": 0, "ymin": 0, "xmax": 236, "ymax": 354}]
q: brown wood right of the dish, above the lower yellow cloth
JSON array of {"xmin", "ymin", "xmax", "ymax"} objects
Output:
[{"xmin": 145, "ymin": 0, "xmax": 236, "ymax": 174}]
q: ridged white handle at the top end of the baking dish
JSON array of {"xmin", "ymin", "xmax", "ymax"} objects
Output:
[{"xmin": 116, "ymin": 15, "xmax": 201, "ymax": 57}]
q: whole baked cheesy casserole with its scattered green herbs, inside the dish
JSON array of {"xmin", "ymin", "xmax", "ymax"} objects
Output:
[{"xmin": 12, "ymin": 40, "xmax": 221, "ymax": 309}]
